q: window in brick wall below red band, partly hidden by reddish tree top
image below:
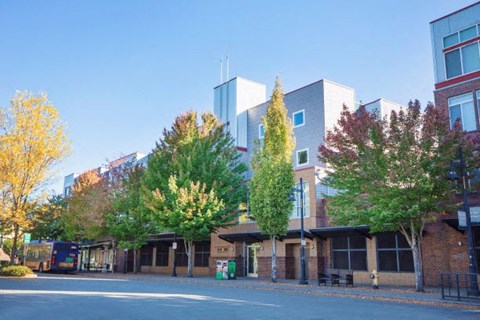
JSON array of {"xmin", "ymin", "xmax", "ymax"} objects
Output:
[{"xmin": 448, "ymin": 93, "xmax": 477, "ymax": 131}]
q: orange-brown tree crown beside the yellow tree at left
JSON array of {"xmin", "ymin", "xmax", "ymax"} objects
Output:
[{"xmin": 62, "ymin": 169, "xmax": 111, "ymax": 241}]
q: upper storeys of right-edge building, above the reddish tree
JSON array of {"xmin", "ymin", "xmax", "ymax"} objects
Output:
[{"xmin": 430, "ymin": 2, "xmax": 480, "ymax": 132}]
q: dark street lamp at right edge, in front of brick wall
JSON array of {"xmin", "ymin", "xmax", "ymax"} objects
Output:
[{"xmin": 447, "ymin": 146, "xmax": 478, "ymax": 295}]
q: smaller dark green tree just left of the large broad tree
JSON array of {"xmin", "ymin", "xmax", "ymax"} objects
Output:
[{"xmin": 107, "ymin": 166, "xmax": 156, "ymax": 273}]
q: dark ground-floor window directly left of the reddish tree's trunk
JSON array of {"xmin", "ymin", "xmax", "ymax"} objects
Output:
[{"xmin": 376, "ymin": 233, "xmax": 414, "ymax": 272}]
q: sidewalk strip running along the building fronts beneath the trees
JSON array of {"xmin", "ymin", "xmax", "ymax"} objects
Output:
[{"xmin": 64, "ymin": 273, "xmax": 480, "ymax": 310}]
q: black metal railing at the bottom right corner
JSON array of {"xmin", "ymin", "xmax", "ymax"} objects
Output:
[{"xmin": 440, "ymin": 273, "xmax": 480, "ymax": 302}]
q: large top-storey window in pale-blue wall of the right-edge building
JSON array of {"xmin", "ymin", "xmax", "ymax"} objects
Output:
[{"xmin": 445, "ymin": 42, "xmax": 480, "ymax": 79}]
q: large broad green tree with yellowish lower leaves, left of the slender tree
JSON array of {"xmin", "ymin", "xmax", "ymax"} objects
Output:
[{"xmin": 142, "ymin": 111, "xmax": 246, "ymax": 277}]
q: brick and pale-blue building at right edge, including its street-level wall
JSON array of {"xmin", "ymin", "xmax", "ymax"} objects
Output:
[{"xmin": 427, "ymin": 2, "xmax": 480, "ymax": 282}]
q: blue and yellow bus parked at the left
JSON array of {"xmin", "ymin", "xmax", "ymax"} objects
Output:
[{"xmin": 23, "ymin": 240, "xmax": 78, "ymax": 272}]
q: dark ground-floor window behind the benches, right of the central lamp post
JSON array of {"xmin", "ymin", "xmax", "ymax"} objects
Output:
[{"xmin": 332, "ymin": 236, "xmax": 367, "ymax": 270}]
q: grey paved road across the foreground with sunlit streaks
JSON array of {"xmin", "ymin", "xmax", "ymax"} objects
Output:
[{"xmin": 0, "ymin": 275, "xmax": 480, "ymax": 320}]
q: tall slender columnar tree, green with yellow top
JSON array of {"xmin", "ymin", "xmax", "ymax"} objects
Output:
[{"xmin": 250, "ymin": 78, "xmax": 294, "ymax": 282}]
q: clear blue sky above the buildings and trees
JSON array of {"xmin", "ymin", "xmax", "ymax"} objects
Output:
[{"xmin": 0, "ymin": 0, "xmax": 475, "ymax": 193}]
